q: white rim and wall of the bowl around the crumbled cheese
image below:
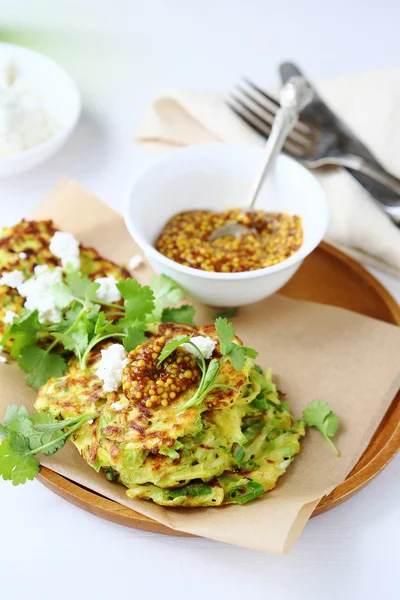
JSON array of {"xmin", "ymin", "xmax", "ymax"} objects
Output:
[{"xmin": 0, "ymin": 43, "xmax": 81, "ymax": 178}]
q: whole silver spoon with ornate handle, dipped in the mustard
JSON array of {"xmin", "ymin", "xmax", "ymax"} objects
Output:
[{"xmin": 208, "ymin": 75, "xmax": 313, "ymax": 242}]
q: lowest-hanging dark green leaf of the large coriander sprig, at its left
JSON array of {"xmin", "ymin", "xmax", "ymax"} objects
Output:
[{"xmin": 18, "ymin": 346, "xmax": 67, "ymax": 390}]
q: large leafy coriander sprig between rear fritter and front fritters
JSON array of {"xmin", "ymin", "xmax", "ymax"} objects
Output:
[{"xmin": 0, "ymin": 271, "xmax": 195, "ymax": 390}]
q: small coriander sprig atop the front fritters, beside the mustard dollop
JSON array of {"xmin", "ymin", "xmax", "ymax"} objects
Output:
[{"xmin": 158, "ymin": 317, "xmax": 258, "ymax": 409}]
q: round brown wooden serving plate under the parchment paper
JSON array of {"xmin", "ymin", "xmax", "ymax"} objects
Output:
[{"xmin": 39, "ymin": 242, "xmax": 400, "ymax": 536}]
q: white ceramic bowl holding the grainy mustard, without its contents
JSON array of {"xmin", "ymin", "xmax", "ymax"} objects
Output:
[{"xmin": 125, "ymin": 143, "xmax": 329, "ymax": 307}]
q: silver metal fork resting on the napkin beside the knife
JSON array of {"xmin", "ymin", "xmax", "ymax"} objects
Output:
[{"xmin": 227, "ymin": 78, "xmax": 400, "ymax": 199}]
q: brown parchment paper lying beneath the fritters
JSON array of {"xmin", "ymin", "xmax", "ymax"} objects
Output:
[{"xmin": 0, "ymin": 181, "xmax": 400, "ymax": 554}]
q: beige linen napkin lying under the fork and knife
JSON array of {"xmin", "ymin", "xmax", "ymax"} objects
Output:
[{"xmin": 136, "ymin": 68, "xmax": 400, "ymax": 277}]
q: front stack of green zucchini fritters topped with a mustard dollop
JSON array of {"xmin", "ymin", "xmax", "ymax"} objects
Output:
[{"xmin": 35, "ymin": 324, "xmax": 304, "ymax": 506}]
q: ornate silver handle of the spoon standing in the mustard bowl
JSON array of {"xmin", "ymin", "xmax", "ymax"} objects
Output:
[{"xmin": 247, "ymin": 76, "xmax": 312, "ymax": 212}]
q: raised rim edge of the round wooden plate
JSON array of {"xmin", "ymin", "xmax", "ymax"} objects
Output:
[{"xmin": 38, "ymin": 242, "xmax": 400, "ymax": 536}]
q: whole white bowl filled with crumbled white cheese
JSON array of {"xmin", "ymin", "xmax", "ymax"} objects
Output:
[{"xmin": 0, "ymin": 43, "xmax": 81, "ymax": 178}]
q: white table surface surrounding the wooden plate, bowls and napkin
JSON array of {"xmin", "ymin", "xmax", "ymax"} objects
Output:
[{"xmin": 0, "ymin": 0, "xmax": 400, "ymax": 600}]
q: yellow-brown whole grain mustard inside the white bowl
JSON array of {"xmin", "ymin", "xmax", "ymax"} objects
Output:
[{"xmin": 155, "ymin": 209, "xmax": 303, "ymax": 273}]
